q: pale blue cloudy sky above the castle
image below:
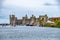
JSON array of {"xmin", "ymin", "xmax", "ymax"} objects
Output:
[{"xmin": 0, "ymin": 0, "xmax": 60, "ymax": 23}]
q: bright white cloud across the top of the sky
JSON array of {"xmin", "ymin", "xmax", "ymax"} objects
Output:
[{"xmin": 4, "ymin": 0, "xmax": 55, "ymax": 8}]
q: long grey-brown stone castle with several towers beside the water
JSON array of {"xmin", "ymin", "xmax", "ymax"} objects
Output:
[{"xmin": 10, "ymin": 15, "xmax": 48, "ymax": 26}]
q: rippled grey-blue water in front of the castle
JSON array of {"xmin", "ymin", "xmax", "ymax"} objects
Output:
[{"xmin": 0, "ymin": 26, "xmax": 60, "ymax": 40}]
